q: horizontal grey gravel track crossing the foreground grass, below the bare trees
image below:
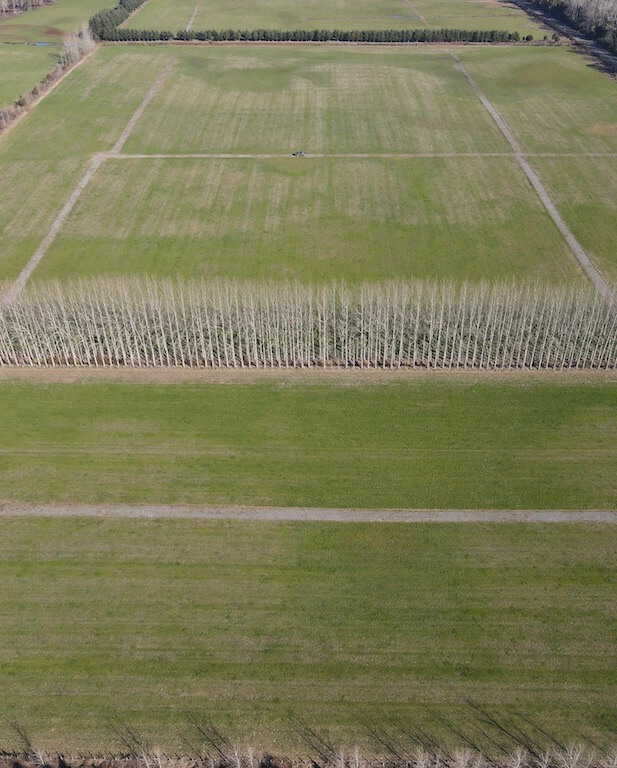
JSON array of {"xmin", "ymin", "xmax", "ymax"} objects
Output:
[{"xmin": 0, "ymin": 503, "xmax": 617, "ymax": 525}]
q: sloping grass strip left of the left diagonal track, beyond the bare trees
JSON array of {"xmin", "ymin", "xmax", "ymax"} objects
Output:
[{"xmin": 0, "ymin": 49, "xmax": 171, "ymax": 279}]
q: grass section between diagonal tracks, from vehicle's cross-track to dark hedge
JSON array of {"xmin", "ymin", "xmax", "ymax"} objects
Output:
[{"xmin": 125, "ymin": 46, "xmax": 509, "ymax": 154}]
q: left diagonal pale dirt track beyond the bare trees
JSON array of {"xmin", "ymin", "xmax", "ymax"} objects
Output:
[{"xmin": 0, "ymin": 60, "xmax": 174, "ymax": 306}]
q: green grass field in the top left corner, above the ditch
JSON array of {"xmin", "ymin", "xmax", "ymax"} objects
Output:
[{"xmin": 0, "ymin": 0, "xmax": 110, "ymax": 43}]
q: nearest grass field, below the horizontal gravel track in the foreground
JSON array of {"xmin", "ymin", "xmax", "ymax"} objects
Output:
[{"xmin": 0, "ymin": 516, "xmax": 617, "ymax": 751}]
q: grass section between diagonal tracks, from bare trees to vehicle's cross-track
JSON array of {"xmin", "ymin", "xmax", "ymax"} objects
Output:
[{"xmin": 37, "ymin": 158, "xmax": 576, "ymax": 282}]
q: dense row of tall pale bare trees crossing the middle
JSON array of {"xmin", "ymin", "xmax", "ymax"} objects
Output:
[{"xmin": 0, "ymin": 279, "xmax": 617, "ymax": 370}]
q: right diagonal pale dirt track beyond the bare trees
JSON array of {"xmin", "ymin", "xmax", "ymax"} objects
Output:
[{"xmin": 450, "ymin": 51, "xmax": 612, "ymax": 301}]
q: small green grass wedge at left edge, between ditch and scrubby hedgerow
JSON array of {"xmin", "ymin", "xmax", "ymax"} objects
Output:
[{"xmin": 0, "ymin": 43, "xmax": 60, "ymax": 109}]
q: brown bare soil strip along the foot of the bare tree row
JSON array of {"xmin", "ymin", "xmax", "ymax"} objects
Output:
[{"xmin": 0, "ymin": 367, "xmax": 617, "ymax": 386}]
